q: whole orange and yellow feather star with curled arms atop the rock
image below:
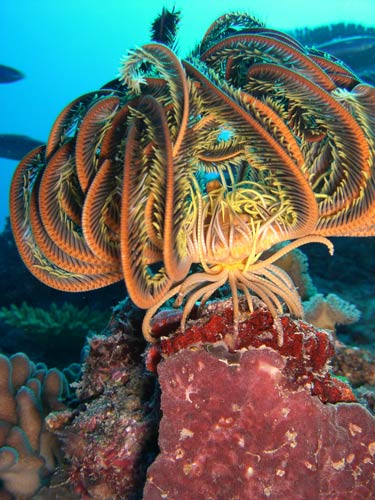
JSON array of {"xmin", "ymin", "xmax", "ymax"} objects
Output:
[{"xmin": 10, "ymin": 14, "xmax": 375, "ymax": 341}]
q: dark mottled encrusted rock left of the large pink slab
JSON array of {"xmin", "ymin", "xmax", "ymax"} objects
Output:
[{"xmin": 49, "ymin": 332, "xmax": 159, "ymax": 500}]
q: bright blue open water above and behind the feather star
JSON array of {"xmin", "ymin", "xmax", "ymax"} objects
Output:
[{"xmin": 0, "ymin": 0, "xmax": 375, "ymax": 230}]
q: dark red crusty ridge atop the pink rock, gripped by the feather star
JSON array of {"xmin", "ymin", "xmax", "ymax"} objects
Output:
[{"xmin": 146, "ymin": 299, "xmax": 355, "ymax": 403}]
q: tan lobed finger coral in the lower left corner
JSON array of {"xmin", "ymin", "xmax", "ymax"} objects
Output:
[{"xmin": 0, "ymin": 353, "xmax": 68, "ymax": 500}]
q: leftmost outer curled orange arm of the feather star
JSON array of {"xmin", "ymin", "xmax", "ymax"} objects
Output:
[{"xmin": 10, "ymin": 147, "xmax": 122, "ymax": 292}]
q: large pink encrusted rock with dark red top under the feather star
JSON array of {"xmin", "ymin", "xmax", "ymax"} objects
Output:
[{"xmin": 144, "ymin": 302, "xmax": 375, "ymax": 500}]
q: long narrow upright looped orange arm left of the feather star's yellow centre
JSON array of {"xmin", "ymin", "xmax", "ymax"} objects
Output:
[{"xmin": 121, "ymin": 96, "xmax": 190, "ymax": 308}]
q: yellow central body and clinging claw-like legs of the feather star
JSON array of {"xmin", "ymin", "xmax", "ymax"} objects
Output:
[{"xmin": 144, "ymin": 177, "xmax": 333, "ymax": 342}]
